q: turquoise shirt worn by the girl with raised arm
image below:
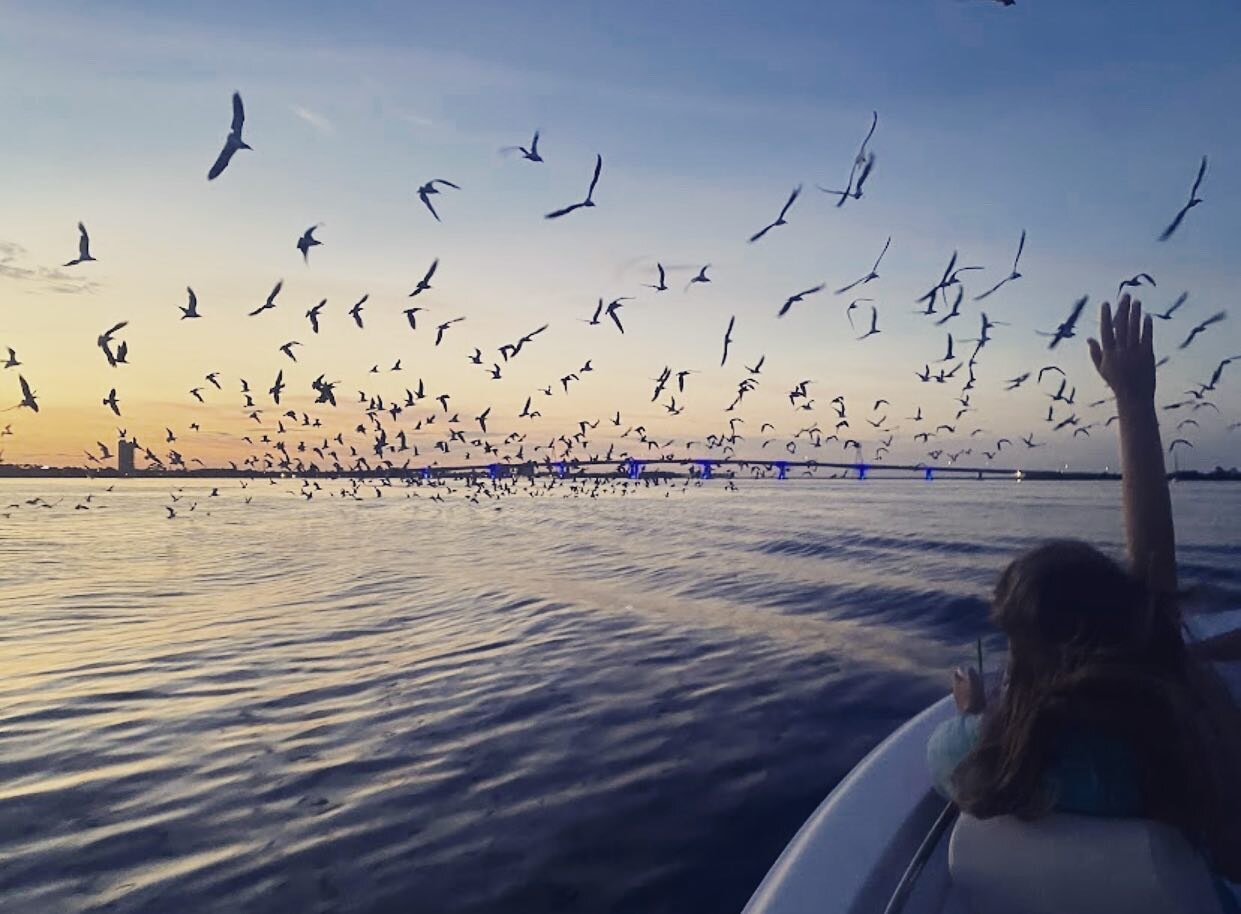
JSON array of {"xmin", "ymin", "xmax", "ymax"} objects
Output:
[{"xmin": 927, "ymin": 714, "xmax": 1241, "ymax": 914}]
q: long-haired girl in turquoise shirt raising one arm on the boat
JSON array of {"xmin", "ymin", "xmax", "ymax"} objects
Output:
[{"xmin": 928, "ymin": 295, "xmax": 1241, "ymax": 912}]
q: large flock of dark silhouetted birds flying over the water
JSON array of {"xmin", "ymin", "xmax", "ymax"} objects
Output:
[{"xmin": 0, "ymin": 83, "xmax": 1241, "ymax": 517}]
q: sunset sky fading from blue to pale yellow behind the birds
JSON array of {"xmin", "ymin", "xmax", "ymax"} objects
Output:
[{"xmin": 0, "ymin": 0, "xmax": 1241, "ymax": 469}]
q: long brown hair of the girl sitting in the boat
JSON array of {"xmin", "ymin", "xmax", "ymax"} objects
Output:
[{"xmin": 953, "ymin": 541, "xmax": 1215, "ymax": 846}]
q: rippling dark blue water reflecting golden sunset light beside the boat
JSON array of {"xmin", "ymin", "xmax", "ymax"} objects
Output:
[{"xmin": 0, "ymin": 480, "xmax": 1241, "ymax": 914}]
